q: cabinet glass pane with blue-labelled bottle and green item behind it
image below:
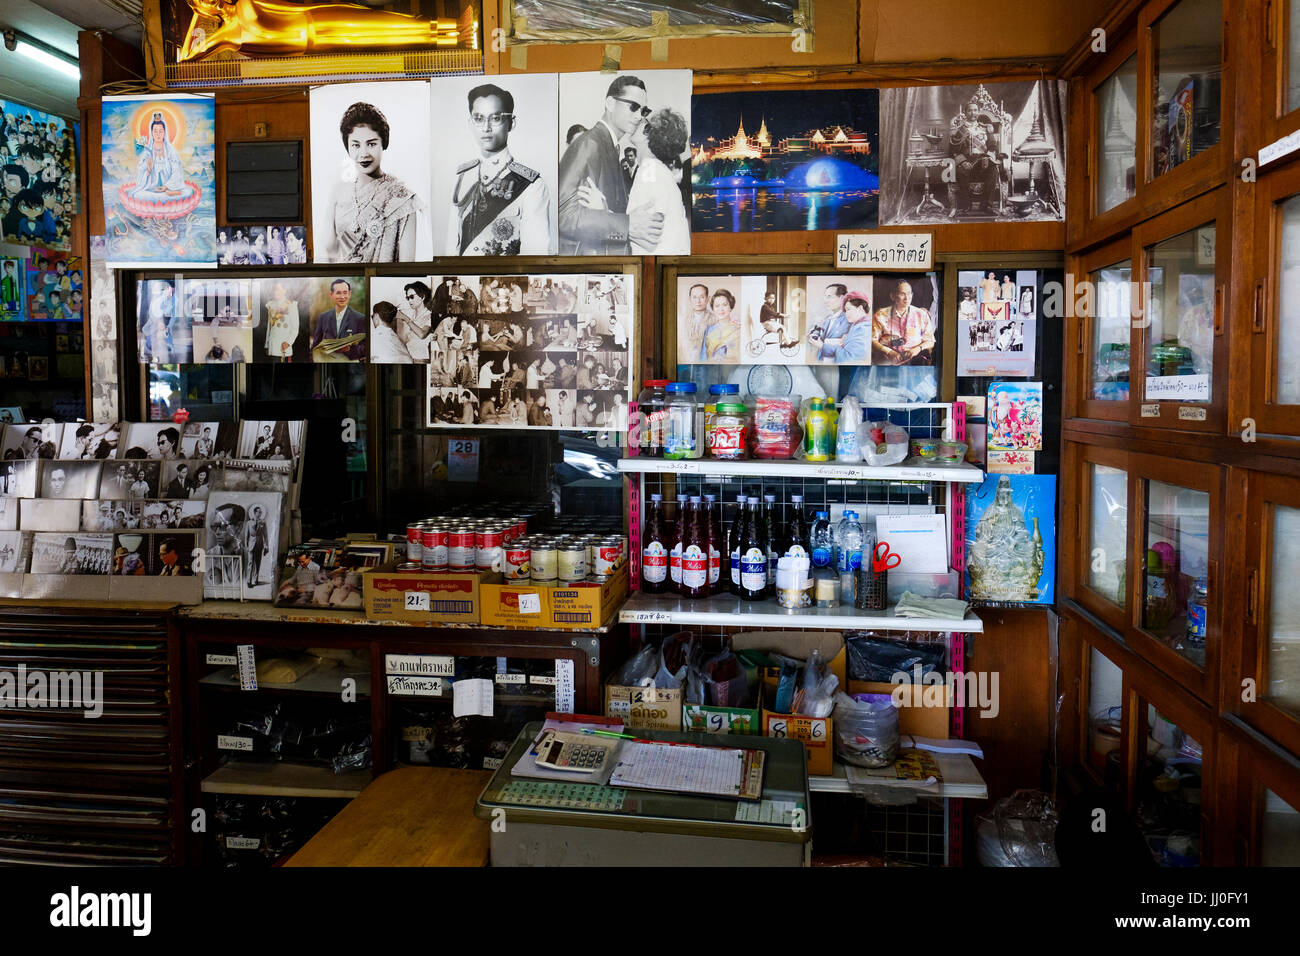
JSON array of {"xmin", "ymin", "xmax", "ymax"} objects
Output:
[{"xmin": 1143, "ymin": 481, "xmax": 1210, "ymax": 667}]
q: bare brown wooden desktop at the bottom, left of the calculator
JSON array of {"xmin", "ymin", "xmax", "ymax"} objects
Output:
[{"xmin": 285, "ymin": 767, "xmax": 491, "ymax": 866}]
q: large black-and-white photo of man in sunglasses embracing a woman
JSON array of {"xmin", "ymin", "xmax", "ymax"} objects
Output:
[{"xmin": 559, "ymin": 70, "xmax": 690, "ymax": 255}]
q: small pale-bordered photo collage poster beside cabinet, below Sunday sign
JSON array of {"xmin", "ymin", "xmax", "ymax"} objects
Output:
[{"xmin": 957, "ymin": 268, "xmax": 1040, "ymax": 378}]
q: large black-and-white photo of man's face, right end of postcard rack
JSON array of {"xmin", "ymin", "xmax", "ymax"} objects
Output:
[{"xmin": 203, "ymin": 490, "xmax": 283, "ymax": 601}]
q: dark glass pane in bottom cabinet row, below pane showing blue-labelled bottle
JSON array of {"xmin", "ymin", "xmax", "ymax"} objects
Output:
[{"xmin": 1136, "ymin": 704, "xmax": 1201, "ymax": 866}]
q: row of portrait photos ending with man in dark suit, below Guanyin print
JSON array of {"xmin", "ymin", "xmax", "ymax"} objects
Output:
[{"xmin": 137, "ymin": 276, "xmax": 367, "ymax": 364}]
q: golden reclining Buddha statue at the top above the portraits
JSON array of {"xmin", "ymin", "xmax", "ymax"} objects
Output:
[{"xmin": 177, "ymin": 0, "xmax": 477, "ymax": 62}]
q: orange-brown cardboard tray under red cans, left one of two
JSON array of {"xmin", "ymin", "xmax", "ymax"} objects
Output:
[{"xmin": 361, "ymin": 563, "xmax": 501, "ymax": 624}]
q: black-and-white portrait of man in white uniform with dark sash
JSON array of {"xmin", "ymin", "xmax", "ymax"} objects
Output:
[{"xmin": 430, "ymin": 73, "xmax": 559, "ymax": 256}]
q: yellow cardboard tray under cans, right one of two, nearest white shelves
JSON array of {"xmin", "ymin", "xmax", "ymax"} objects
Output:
[{"xmin": 480, "ymin": 564, "xmax": 628, "ymax": 631}]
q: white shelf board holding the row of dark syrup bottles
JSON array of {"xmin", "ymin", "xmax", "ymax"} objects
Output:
[{"xmin": 619, "ymin": 591, "xmax": 984, "ymax": 633}]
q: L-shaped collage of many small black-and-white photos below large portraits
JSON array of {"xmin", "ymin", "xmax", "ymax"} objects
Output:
[{"xmin": 392, "ymin": 273, "xmax": 634, "ymax": 429}]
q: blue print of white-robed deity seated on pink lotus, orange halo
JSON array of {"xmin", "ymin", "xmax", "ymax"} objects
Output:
[{"xmin": 100, "ymin": 94, "xmax": 217, "ymax": 267}]
